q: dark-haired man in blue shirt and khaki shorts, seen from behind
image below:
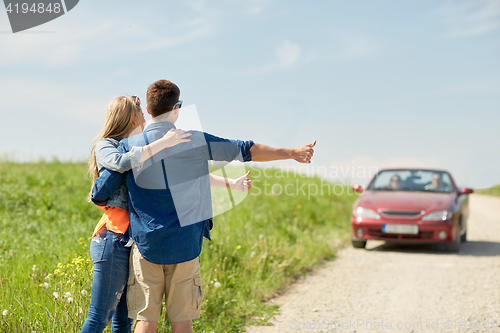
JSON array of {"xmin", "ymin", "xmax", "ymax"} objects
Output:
[{"xmin": 93, "ymin": 80, "xmax": 315, "ymax": 333}]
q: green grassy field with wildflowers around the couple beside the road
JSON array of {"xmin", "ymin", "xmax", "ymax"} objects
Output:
[{"xmin": 0, "ymin": 162, "xmax": 356, "ymax": 333}]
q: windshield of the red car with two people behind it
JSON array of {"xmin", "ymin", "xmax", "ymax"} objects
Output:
[{"xmin": 368, "ymin": 170, "xmax": 452, "ymax": 193}]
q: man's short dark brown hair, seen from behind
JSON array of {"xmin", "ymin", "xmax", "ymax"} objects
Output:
[{"xmin": 146, "ymin": 80, "xmax": 181, "ymax": 117}]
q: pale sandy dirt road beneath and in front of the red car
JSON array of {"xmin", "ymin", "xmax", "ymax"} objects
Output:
[{"xmin": 247, "ymin": 194, "xmax": 500, "ymax": 333}]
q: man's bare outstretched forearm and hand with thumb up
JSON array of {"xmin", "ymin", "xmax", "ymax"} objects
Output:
[{"xmin": 250, "ymin": 140, "xmax": 316, "ymax": 163}]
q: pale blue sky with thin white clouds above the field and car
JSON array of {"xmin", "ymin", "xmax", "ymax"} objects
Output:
[{"xmin": 0, "ymin": 0, "xmax": 500, "ymax": 187}]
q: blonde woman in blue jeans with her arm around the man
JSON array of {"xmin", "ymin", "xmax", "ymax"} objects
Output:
[{"xmin": 81, "ymin": 96, "xmax": 252, "ymax": 333}]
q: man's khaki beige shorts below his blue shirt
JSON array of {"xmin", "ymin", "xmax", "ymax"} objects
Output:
[{"xmin": 127, "ymin": 244, "xmax": 203, "ymax": 322}]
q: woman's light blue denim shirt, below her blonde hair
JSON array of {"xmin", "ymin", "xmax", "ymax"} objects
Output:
[{"xmin": 95, "ymin": 138, "xmax": 142, "ymax": 211}]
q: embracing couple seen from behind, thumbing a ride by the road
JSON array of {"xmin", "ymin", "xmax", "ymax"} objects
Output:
[{"xmin": 81, "ymin": 80, "xmax": 315, "ymax": 333}]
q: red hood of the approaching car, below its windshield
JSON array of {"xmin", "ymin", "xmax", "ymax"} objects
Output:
[{"xmin": 357, "ymin": 191, "xmax": 453, "ymax": 212}]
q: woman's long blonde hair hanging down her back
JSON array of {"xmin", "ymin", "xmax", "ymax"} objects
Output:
[{"xmin": 89, "ymin": 96, "xmax": 142, "ymax": 193}]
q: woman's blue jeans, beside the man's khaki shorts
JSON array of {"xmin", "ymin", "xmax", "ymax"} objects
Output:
[{"xmin": 81, "ymin": 230, "xmax": 133, "ymax": 333}]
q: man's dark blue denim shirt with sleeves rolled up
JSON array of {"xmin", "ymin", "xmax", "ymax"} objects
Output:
[{"xmin": 93, "ymin": 122, "xmax": 253, "ymax": 265}]
